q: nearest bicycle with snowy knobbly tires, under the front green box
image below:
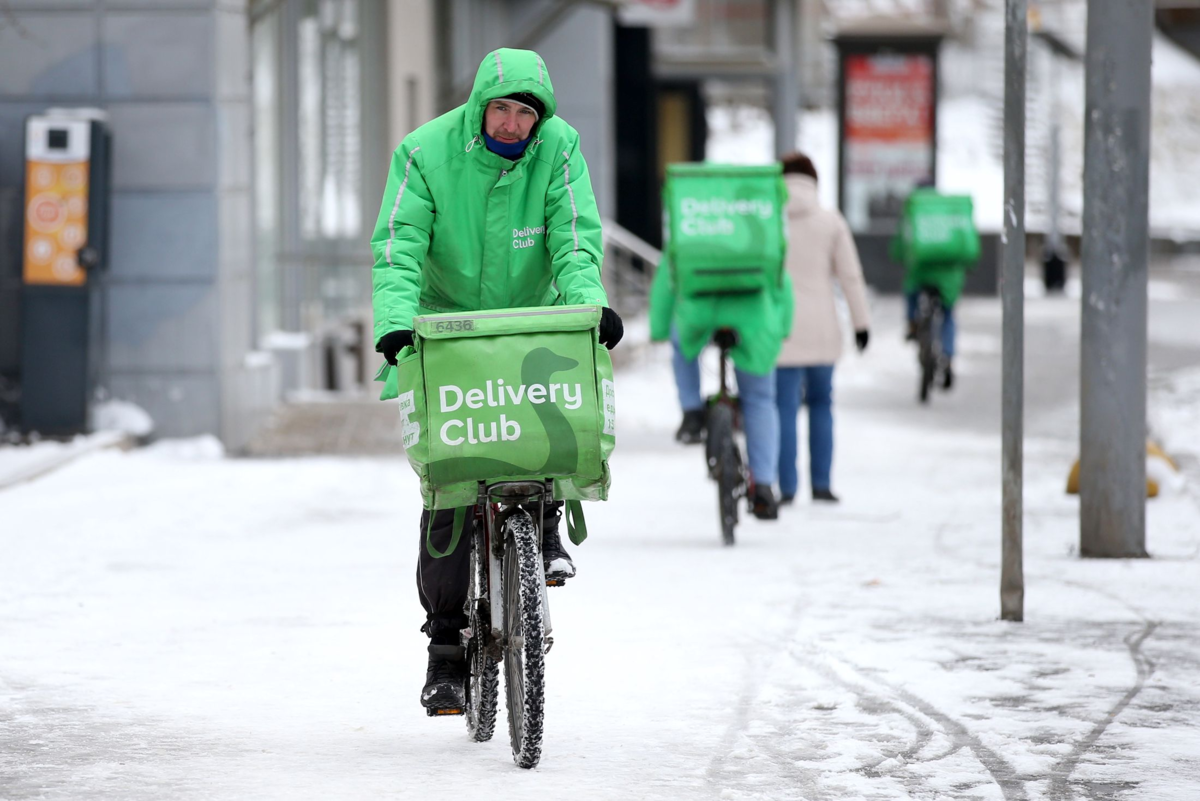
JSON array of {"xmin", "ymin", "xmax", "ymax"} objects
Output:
[{"xmin": 462, "ymin": 481, "xmax": 564, "ymax": 769}]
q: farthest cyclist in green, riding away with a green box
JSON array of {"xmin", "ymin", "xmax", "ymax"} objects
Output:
[{"xmin": 888, "ymin": 179, "xmax": 979, "ymax": 390}]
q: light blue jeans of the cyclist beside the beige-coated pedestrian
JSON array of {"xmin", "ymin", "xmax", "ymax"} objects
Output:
[{"xmin": 671, "ymin": 331, "xmax": 779, "ymax": 486}]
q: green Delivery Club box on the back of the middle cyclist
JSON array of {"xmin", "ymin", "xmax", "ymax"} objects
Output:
[{"xmin": 662, "ymin": 164, "xmax": 787, "ymax": 295}]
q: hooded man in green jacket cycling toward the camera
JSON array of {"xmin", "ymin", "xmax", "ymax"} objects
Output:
[{"xmin": 371, "ymin": 48, "xmax": 623, "ymax": 710}]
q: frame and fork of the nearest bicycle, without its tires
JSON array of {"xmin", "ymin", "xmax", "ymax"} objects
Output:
[{"xmin": 476, "ymin": 478, "xmax": 554, "ymax": 652}]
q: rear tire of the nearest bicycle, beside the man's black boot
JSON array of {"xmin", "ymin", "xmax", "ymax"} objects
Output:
[{"xmin": 467, "ymin": 527, "xmax": 500, "ymax": 742}]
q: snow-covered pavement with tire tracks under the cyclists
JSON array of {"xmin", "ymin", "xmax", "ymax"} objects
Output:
[{"xmin": 0, "ymin": 288, "xmax": 1200, "ymax": 801}]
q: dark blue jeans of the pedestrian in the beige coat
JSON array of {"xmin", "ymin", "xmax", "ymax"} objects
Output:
[{"xmin": 775, "ymin": 365, "xmax": 833, "ymax": 495}]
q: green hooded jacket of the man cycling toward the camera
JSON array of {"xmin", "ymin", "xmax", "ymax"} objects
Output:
[{"xmin": 371, "ymin": 48, "xmax": 608, "ymax": 342}]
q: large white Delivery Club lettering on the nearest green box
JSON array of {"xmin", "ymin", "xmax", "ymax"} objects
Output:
[{"xmin": 438, "ymin": 379, "xmax": 583, "ymax": 446}]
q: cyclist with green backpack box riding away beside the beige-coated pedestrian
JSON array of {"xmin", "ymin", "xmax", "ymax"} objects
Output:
[{"xmin": 650, "ymin": 164, "xmax": 792, "ymax": 520}]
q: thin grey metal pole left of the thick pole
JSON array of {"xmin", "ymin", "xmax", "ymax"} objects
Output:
[{"xmin": 1000, "ymin": 0, "xmax": 1028, "ymax": 621}]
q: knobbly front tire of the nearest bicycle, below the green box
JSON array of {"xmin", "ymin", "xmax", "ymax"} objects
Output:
[{"xmin": 503, "ymin": 510, "xmax": 546, "ymax": 769}]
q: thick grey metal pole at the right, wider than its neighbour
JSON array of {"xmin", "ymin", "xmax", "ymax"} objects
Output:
[{"xmin": 1079, "ymin": 0, "xmax": 1154, "ymax": 558}]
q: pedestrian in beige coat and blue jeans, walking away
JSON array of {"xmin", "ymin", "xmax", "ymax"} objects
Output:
[{"xmin": 775, "ymin": 153, "xmax": 870, "ymax": 504}]
